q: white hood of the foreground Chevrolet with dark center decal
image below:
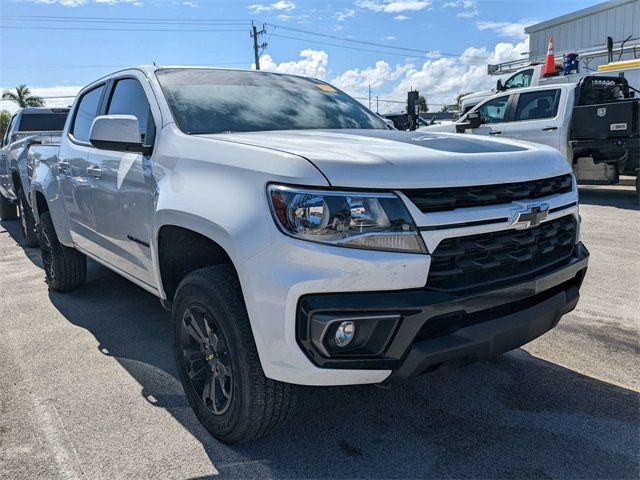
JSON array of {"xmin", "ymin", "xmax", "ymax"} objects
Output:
[{"xmin": 201, "ymin": 130, "xmax": 570, "ymax": 189}]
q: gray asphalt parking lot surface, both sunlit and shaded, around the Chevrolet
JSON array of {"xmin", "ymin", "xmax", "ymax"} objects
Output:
[{"xmin": 0, "ymin": 187, "xmax": 640, "ymax": 479}]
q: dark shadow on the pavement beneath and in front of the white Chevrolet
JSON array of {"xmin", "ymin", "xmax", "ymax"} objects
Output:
[{"xmin": 3, "ymin": 218, "xmax": 640, "ymax": 478}]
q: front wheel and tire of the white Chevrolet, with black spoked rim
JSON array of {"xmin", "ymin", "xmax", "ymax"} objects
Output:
[{"xmin": 172, "ymin": 265, "xmax": 295, "ymax": 443}]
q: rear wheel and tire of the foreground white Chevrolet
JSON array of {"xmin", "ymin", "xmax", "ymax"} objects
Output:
[{"xmin": 38, "ymin": 212, "xmax": 87, "ymax": 292}]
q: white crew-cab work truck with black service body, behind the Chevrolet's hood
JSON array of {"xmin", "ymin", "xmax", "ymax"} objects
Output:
[{"xmin": 420, "ymin": 75, "xmax": 640, "ymax": 191}]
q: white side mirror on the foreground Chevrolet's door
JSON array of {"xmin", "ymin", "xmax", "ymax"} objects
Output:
[{"xmin": 89, "ymin": 115, "xmax": 150, "ymax": 154}]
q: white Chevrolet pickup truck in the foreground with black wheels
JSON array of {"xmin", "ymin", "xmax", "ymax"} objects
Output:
[{"xmin": 30, "ymin": 66, "xmax": 588, "ymax": 442}]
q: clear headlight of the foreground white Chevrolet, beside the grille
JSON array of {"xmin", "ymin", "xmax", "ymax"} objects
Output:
[{"xmin": 268, "ymin": 185, "xmax": 427, "ymax": 253}]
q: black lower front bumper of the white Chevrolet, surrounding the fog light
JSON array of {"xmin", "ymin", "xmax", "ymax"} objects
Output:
[{"xmin": 297, "ymin": 244, "xmax": 589, "ymax": 387}]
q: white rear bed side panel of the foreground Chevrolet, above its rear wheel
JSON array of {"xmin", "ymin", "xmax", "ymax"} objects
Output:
[{"xmin": 28, "ymin": 146, "xmax": 73, "ymax": 247}]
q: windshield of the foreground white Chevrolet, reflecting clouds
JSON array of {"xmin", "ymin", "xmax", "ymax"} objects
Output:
[{"xmin": 156, "ymin": 69, "xmax": 388, "ymax": 134}]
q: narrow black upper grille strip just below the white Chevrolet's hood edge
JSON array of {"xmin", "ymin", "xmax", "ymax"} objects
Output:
[{"xmin": 402, "ymin": 174, "xmax": 571, "ymax": 213}]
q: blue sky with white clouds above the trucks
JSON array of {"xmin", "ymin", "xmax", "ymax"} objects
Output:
[{"xmin": 0, "ymin": 0, "xmax": 598, "ymax": 110}]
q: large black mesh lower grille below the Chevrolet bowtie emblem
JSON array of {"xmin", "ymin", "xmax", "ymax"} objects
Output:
[{"xmin": 427, "ymin": 215, "xmax": 577, "ymax": 292}]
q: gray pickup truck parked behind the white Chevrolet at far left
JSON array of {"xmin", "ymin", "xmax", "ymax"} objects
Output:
[{"xmin": 0, "ymin": 107, "xmax": 69, "ymax": 247}]
